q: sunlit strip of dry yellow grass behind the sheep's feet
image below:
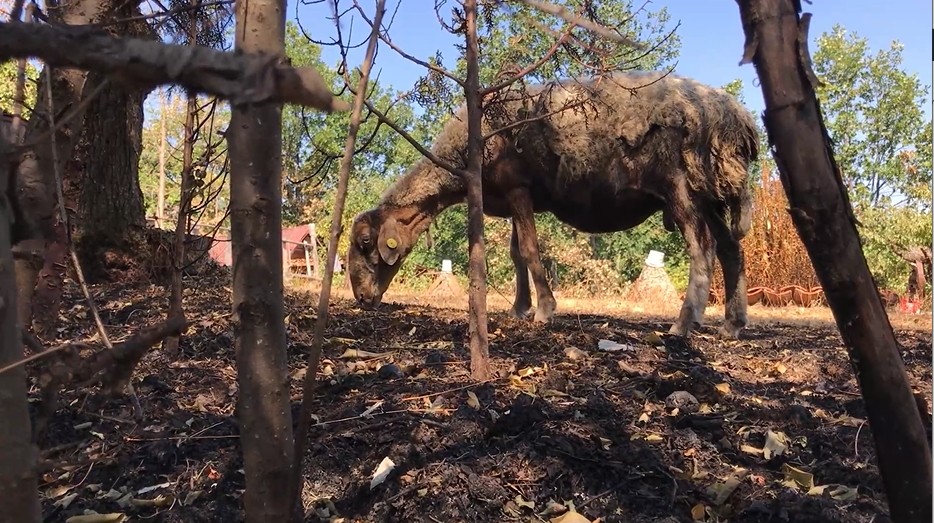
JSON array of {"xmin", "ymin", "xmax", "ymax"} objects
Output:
[{"xmin": 290, "ymin": 280, "xmax": 934, "ymax": 332}]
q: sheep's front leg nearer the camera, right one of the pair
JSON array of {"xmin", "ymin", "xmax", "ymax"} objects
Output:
[{"xmin": 509, "ymin": 189, "xmax": 557, "ymax": 322}]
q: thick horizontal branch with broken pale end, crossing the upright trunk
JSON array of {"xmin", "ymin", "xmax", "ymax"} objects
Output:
[{"xmin": 0, "ymin": 22, "xmax": 350, "ymax": 112}]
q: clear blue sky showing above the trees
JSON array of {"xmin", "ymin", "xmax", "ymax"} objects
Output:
[{"xmin": 288, "ymin": 0, "xmax": 932, "ymax": 118}]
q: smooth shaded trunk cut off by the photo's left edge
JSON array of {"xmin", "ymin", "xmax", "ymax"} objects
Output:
[{"xmin": 0, "ymin": 162, "xmax": 42, "ymax": 523}]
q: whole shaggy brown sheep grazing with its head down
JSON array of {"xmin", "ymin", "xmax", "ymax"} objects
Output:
[{"xmin": 348, "ymin": 72, "xmax": 759, "ymax": 337}]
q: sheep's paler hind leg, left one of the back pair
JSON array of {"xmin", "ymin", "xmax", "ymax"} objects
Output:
[{"xmin": 668, "ymin": 181, "xmax": 716, "ymax": 336}]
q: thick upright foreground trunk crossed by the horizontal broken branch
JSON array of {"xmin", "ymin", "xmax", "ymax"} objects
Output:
[{"xmin": 227, "ymin": 0, "xmax": 292, "ymax": 523}]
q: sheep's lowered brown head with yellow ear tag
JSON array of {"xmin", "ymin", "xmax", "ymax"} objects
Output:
[{"xmin": 347, "ymin": 209, "xmax": 414, "ymax": 309}]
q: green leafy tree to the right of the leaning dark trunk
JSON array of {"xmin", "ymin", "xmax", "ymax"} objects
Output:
[{"xmin": 813, "ymin": 25, "xmax": 932, "ymax": 290}]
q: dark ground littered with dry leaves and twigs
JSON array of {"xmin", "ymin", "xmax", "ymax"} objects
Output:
[{"xmin": 30, "ymin": 278, "xmax": 932, "ymax": 523}]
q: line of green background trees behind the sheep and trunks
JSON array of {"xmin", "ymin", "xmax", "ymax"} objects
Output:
[{"xmin": 7, "ymin": 2, "xmax": 932, "ymax": 295}]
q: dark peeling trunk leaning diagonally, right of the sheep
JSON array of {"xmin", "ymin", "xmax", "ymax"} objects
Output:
[{"xmin": 738, "ymin": 0, "xmax": 932, "ymax": 523}]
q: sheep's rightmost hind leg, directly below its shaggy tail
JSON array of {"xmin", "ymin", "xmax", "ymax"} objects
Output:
[{"xmin": 710, "ymin": 209, "xmax": 749, "ymax": 339}]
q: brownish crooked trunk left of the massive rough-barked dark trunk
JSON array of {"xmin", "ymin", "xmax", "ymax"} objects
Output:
[{"xmin": 14, "ymin": 0, "xmax": 102, "ymax": 336}]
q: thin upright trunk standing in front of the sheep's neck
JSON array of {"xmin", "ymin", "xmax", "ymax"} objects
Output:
[{"xmin": 464, "ymin": 0, "xmax": 490, "ymax": 381}]
